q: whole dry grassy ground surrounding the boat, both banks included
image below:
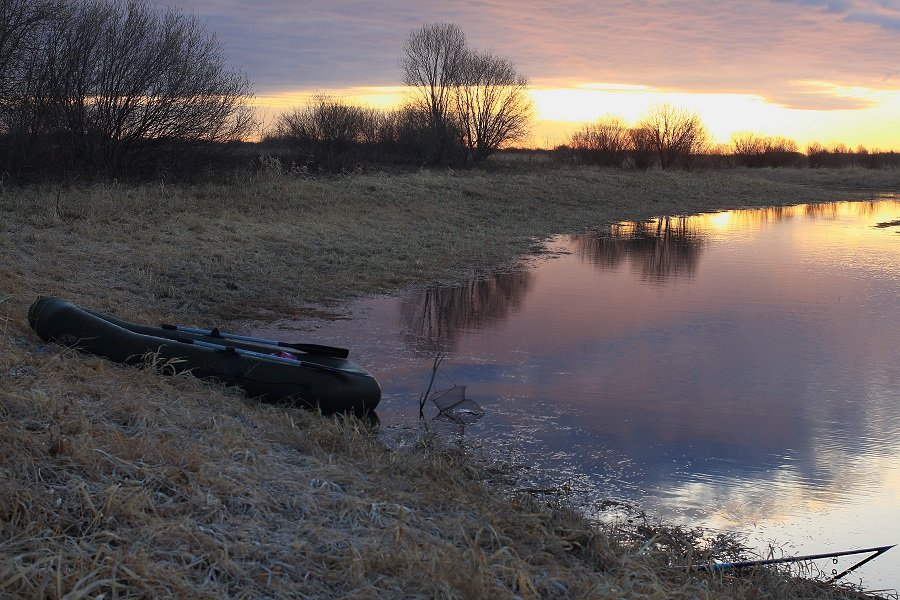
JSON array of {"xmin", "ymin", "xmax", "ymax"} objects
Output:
[{"xmin": 0, "ymin": 167, "xmax": 900, "ymax": 598}]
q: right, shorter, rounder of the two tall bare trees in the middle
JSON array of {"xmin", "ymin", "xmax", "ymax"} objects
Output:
[{"xmin": 454, "ymin": 52, "xmax": 532, "ymax": 162}]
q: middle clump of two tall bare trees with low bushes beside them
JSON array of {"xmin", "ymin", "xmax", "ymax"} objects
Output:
[{"xmin": 264, "ymin": 23, "xmax": 532, "ymax": 171}]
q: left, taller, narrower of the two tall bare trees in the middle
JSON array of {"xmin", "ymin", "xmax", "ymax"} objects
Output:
[{"xmin": 400, "ymin": 23, "xmax": 466, "ymax": 163}]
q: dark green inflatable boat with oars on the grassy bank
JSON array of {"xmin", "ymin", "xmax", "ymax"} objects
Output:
[{"xmin": 28, "ymin": 296, "xmax": 381, "ymax": 414}]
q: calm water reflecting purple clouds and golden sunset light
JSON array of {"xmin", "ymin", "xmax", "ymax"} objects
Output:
[{"xmin": 251, "ymin": 200, "xmax": 900, "ymax": 589}]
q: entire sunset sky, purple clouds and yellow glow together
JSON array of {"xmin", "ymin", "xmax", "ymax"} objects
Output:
[{"xmin": 154, "ymin": 0, "xmax": 900, "ymax": 150}]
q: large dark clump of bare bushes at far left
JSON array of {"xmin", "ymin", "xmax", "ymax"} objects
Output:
[{"xmin": 2, "ymin": 0, "xmax": 253, "ymax": 178}]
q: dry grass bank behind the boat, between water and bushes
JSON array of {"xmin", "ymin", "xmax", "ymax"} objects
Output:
[{"xmin": 0, "ymin": 169, "xmax": 876, "ymax": 320}]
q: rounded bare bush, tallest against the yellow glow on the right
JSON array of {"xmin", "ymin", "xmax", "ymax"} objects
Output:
[{"xmin": 637, "ymin": 104, "xmax": 708, "ymax": 169}]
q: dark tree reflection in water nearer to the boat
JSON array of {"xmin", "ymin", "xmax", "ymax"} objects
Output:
[{"xmin": 400, "ymin": 271, "xmax": 533, "ymax": 354}]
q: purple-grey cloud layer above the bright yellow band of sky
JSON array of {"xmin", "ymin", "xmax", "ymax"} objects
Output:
[{"xmin": 158, "ymin": 0, "xmax": 900, "ymax": 108}]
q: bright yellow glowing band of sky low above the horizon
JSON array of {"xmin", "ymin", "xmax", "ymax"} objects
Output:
[{"xmin": 254, "ymin": 81, "xmax": 900, "ymax": 150}]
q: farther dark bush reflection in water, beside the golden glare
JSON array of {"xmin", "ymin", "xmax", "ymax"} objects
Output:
[{"xmin": 570, "ymin": 216, "xmax": 706, "ymax": 284}]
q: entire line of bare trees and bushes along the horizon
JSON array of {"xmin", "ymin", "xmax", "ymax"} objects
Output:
[{"xmin": 0, "ymin": 0, "xmax": 898, "ymax": 178}]
